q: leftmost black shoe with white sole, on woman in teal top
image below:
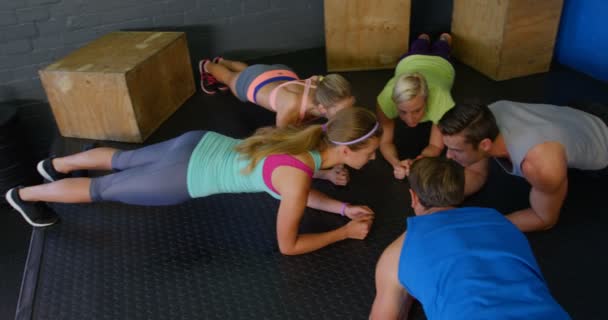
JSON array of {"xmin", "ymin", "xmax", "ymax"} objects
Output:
[{"xmin": 5, "ymin": 187, "xmax": 59, "ymax": 227}]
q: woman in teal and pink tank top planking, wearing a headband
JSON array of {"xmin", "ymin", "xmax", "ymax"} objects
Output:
[{"xmin": 6, "ymin": 108, "xmax": 382, "ymax": 255}]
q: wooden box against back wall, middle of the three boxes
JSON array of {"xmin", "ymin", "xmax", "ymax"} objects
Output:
[{"xmin": 324, "ymin": 0, "xmax": 410, "ymax": 71}]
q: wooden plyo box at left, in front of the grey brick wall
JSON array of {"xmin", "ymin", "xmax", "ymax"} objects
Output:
[{"xmin": 39, "ymin": 32, "xmax": 195, "ymax": 142}]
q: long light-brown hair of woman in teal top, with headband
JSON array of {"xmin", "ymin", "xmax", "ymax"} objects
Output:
[{"xmin": 235, "ymin": 107, "xmax": 382, "ymax": 173}]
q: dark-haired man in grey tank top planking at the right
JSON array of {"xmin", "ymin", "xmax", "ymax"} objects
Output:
[{"xmin": 438, "ymin": 101, "xmax": 608, "ymax": 231}]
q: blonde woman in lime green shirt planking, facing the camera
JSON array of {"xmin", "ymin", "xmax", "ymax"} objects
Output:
[{"xmin": 376, "ymin": 33, "xmax": 455, "ymax": 179}]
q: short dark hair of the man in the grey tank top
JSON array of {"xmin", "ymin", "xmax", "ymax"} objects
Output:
[{"xmin": 438, "ymin": 104, "xmax": 499, "ymax": 149}]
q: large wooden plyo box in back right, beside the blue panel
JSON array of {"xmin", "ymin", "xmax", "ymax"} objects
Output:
[{"xmin": 452, "ymin": 0, "xmax": 563, "ymax": 80}]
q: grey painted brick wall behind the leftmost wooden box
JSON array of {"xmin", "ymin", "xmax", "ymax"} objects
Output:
[{"xmin": 0, "ymin": 0, "xmax": 324, "ymax": 102}]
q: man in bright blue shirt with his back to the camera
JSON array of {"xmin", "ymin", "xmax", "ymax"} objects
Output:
[{"xmin": 370, "ymin": 158, "xmax": 570, "ymax": 320}]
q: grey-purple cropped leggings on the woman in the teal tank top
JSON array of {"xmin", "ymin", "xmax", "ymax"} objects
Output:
[{"xmin": 90, "ymin": 131, "xmax": 206, "ymax": 206}]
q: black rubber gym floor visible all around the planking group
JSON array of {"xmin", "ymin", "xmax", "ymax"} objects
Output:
[{"xmin": 11, "ymin": 50, "xmax": 608, "ymax": 320}]
